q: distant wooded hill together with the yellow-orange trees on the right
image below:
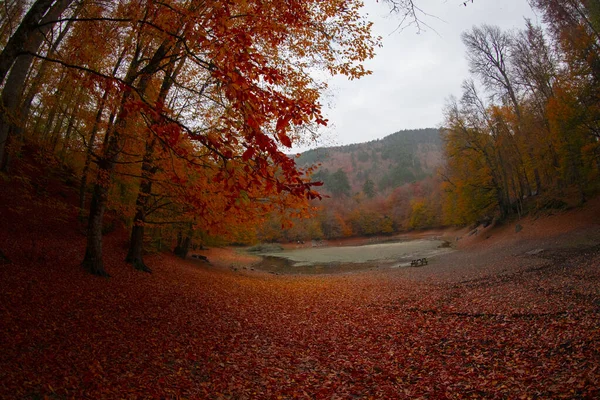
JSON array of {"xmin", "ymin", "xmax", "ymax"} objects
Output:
[{"xmin": 263, "ymin": 0, "xmax": 600, "ymax": 240}]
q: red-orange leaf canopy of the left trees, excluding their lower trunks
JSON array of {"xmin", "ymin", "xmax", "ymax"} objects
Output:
[{"xmin": 10, "ymin": 0, "xmax": 378, "ymax": 266}]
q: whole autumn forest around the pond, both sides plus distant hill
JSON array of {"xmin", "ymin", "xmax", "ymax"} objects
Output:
[{"xmin": 0, "ymin": 0, "xmax": 600, "ymax": 253}]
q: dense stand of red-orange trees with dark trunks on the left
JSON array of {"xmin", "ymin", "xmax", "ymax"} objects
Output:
[{"xmin": 0, "ymin": 0, "xmax": 378, "ymax": 275}]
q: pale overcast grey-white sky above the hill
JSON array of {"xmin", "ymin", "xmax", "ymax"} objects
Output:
[{"xmin": 295, "ymin": 0, "xmax": 540, "ymax": 151}]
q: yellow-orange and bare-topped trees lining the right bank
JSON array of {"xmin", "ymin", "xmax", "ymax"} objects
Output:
[{"xmin": 441, "ymin": 0, "xmax": 600, "ymax": 224}]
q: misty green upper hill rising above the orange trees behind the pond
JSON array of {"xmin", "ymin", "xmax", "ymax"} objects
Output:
[{"xmin": 296, "ymin": 128, "xmax": 443, "ymax": 195}]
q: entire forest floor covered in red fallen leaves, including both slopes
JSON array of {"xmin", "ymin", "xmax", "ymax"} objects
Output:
[{"xmin": 0, "ymin": 158, "xmax": 600, "ymax": 399}]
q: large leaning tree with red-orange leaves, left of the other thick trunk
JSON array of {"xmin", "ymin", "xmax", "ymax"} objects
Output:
[{"xmin": 65, "ymin": 1, "xmax": 376, "ymax": 275}]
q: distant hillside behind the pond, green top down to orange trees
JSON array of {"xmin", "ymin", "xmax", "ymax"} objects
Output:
[{"xmin": 258, "ymin": 128, "xmax": 443, "ymax": 241}]
